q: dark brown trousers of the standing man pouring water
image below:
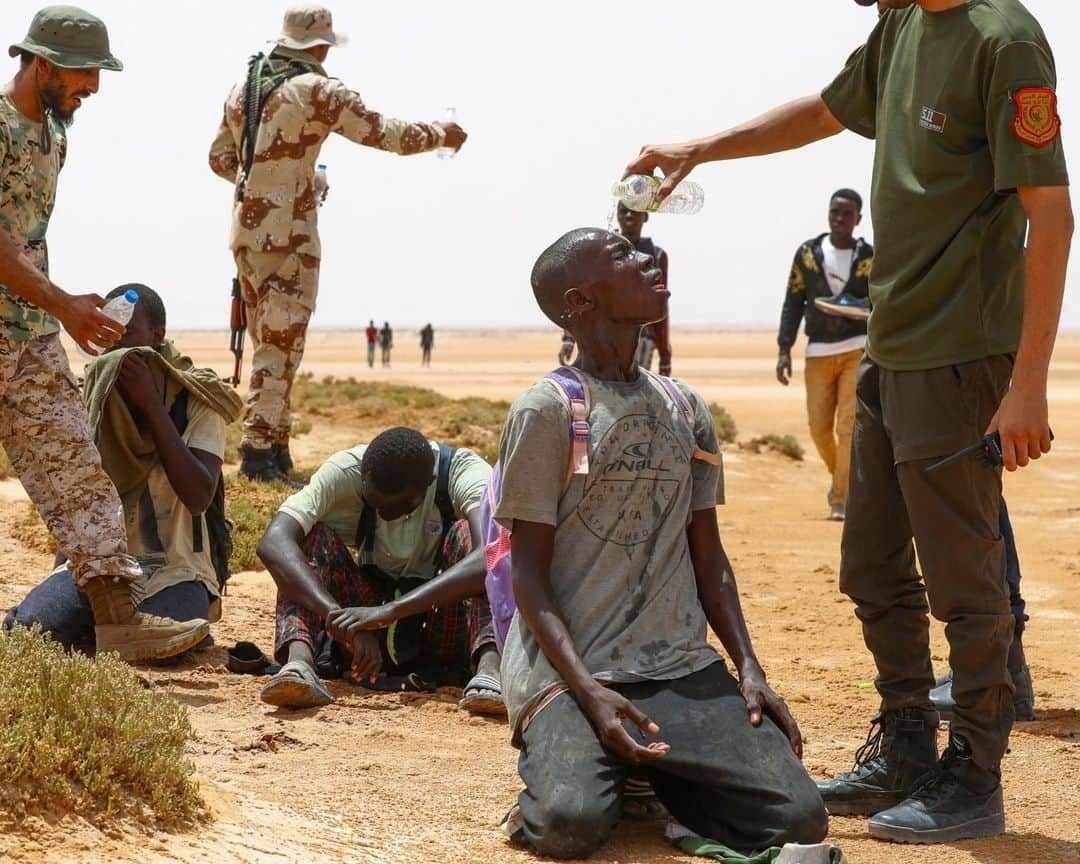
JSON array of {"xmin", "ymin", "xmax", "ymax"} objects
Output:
[{"xmin": 840, "ymin": 355, "xmax": 1014, "ymax": 768}]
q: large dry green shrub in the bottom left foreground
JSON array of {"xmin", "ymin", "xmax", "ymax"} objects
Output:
[{"xmin": 0, "ymin": 627, "xmax": 204, "ymax": 823}]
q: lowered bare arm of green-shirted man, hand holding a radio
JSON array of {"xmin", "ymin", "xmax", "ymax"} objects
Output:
[{"xmin": 987, "ymin": 186, "xmax": 1074, "ymax": 471}]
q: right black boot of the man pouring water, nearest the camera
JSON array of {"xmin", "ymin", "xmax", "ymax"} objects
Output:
[{"xmin": 869, "ymin": 733, "xmax": 1005, "ymax": 843}]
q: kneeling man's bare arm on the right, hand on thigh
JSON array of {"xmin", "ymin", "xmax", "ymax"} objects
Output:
[{"xmin": 687, "ymin": 508, "xmax": 802, "ymax": 758}]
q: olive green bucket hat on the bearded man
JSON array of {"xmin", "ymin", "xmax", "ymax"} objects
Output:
[{"xmin": 8, "ymin": 6, "xmax": 124, "ymax": 72}]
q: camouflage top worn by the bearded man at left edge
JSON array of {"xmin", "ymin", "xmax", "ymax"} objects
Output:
[{"xmin": 0, "ymin": 95, "xmax": 67, "ymax": 341}]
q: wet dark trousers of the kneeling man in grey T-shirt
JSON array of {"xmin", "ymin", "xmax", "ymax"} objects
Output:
[{"xmin": 517, "ymin": 663, "xmax": 828, "ymax": 858}]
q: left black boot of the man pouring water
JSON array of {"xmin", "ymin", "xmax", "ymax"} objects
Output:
[{"xmin": 818, "ymin": 708, "xmax": 937, "ymax": 816}]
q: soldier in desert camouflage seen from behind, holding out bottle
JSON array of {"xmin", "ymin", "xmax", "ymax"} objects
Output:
[{"xmin": 210, "ymin": 5, "xmax": 465, "ymax": 481}]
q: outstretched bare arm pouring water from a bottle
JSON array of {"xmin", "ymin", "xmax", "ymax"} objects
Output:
[{"xmin": 623, "ymin": 93, "xmax": 843, "ymax": 198}]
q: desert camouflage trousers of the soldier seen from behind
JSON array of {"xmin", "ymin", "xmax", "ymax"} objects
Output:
[{"xmin": 235, "ymin": 248, "xmax": 319, "ymax": 449}]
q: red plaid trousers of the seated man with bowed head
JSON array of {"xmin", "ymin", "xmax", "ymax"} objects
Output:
[{"xmin": 274, "ymin": 519, "xmax": 495, "ymax": 675}]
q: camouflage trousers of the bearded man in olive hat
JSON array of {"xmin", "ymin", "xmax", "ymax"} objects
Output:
[{"xmin": 0, "ymin": 334, "xmax": 141, "ymax": 588}]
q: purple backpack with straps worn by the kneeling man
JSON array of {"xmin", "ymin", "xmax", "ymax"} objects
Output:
[{"xmin": 480, "ymin": 366, "xmax": 723, "ymax": 653}]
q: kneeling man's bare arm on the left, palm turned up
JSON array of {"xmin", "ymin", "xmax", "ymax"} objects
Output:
[{"xmin": 510, "ymin": 519, "xmax": 671, "ymax": 764}]
